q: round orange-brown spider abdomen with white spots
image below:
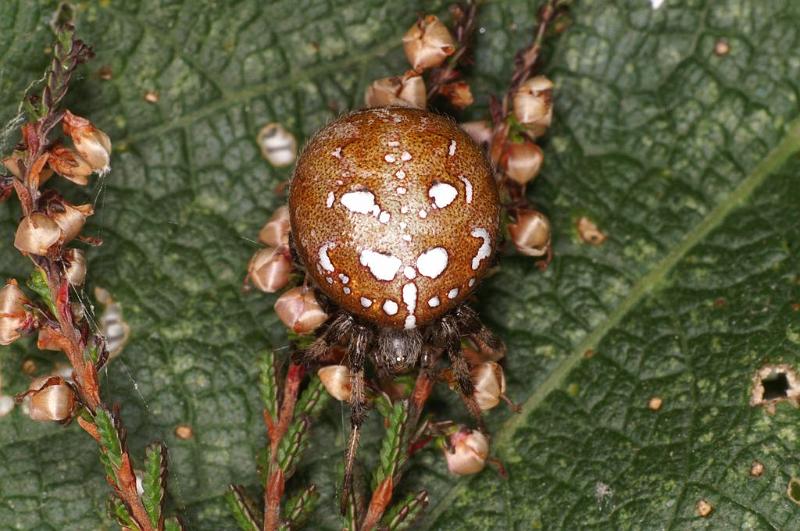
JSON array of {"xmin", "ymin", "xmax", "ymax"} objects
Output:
[{"xmin": 289, "ymin": 107, "xmax": 499, "ymax": 328}]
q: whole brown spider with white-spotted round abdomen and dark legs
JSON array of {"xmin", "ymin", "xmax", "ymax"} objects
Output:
[{"xmin": 289, "ymin": 107, "xmax": 503, "ymax": 504}]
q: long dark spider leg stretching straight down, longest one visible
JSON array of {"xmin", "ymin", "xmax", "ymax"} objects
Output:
[{"xmin": 341, "ymin": 324, "xmax": 373, "ymax": 514}]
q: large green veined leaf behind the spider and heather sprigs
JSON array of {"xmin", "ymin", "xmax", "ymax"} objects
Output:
[{"xmin": 0, "ymin": 0, "xmax": 800, "ymax": 529}]
